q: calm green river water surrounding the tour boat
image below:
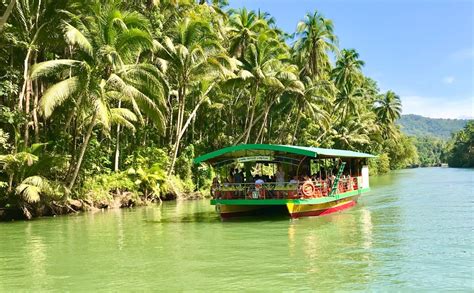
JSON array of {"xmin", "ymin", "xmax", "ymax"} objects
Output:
[{"xmin": 0, "ymin": 168, "xmax": 474, "ymax": 292}]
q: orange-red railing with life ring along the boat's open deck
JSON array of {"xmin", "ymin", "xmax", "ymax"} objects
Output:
[{"xmin": 211, "ymin": 177, "xmax": 361, "ymax": 200}]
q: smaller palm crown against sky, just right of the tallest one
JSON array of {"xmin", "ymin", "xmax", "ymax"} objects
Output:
[{"xmin": 332, "ymin": 49, "xmax": 364, "ymax": 89}]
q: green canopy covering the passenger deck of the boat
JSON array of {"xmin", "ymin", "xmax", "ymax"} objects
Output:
[{"xmin": 194, "ymin": 144, "xmax": 375, "ymax": 165}]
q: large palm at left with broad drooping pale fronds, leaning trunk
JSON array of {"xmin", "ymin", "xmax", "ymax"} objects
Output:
[{"xmin": 31, "ymin": 5, "xmax": 164, "ymax": 190}]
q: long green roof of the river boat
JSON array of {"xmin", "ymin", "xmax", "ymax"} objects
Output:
[{"xmin": 194, "ymin": 144, "xmax": 375, "ymax": 164}]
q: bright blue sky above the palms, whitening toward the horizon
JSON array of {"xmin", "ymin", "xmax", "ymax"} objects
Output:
[{"xmin": 229, "ymin": 0, "xmax": 474, "ymax": 118}]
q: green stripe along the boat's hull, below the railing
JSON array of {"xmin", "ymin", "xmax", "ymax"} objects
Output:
[{"xmin": 211, "ymin": 188, "xmax": 370, "ymax": 206}]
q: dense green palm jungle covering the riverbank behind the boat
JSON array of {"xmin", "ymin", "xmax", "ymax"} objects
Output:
[{"xmin": 0, "ymin": 0, "xmax": 430, "ymax": 213}]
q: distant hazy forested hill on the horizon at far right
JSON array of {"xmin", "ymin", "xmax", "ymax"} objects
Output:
[{"xmin": 397, "ymin": 114, "xmax": 469, "ymax": 139}]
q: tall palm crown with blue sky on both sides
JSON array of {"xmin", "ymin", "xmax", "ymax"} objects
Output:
[{"xmin": 294, "ymin": 11, "xmax": 338, "ymax": 79}]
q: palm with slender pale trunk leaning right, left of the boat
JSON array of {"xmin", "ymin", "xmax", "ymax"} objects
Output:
[{"xmin": 156, "ymin": 18, "xmax": 238, "ymax": 175}]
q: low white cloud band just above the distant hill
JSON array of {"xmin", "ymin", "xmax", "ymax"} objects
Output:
[{"xmin": 401, "ymin": 96, "xmax": 474, "ymax": 119}]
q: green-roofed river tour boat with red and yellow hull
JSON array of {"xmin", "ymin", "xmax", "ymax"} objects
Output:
[{"xmin": 194, "ymin": 144, "xmax": 374, "ymax": 219}]
